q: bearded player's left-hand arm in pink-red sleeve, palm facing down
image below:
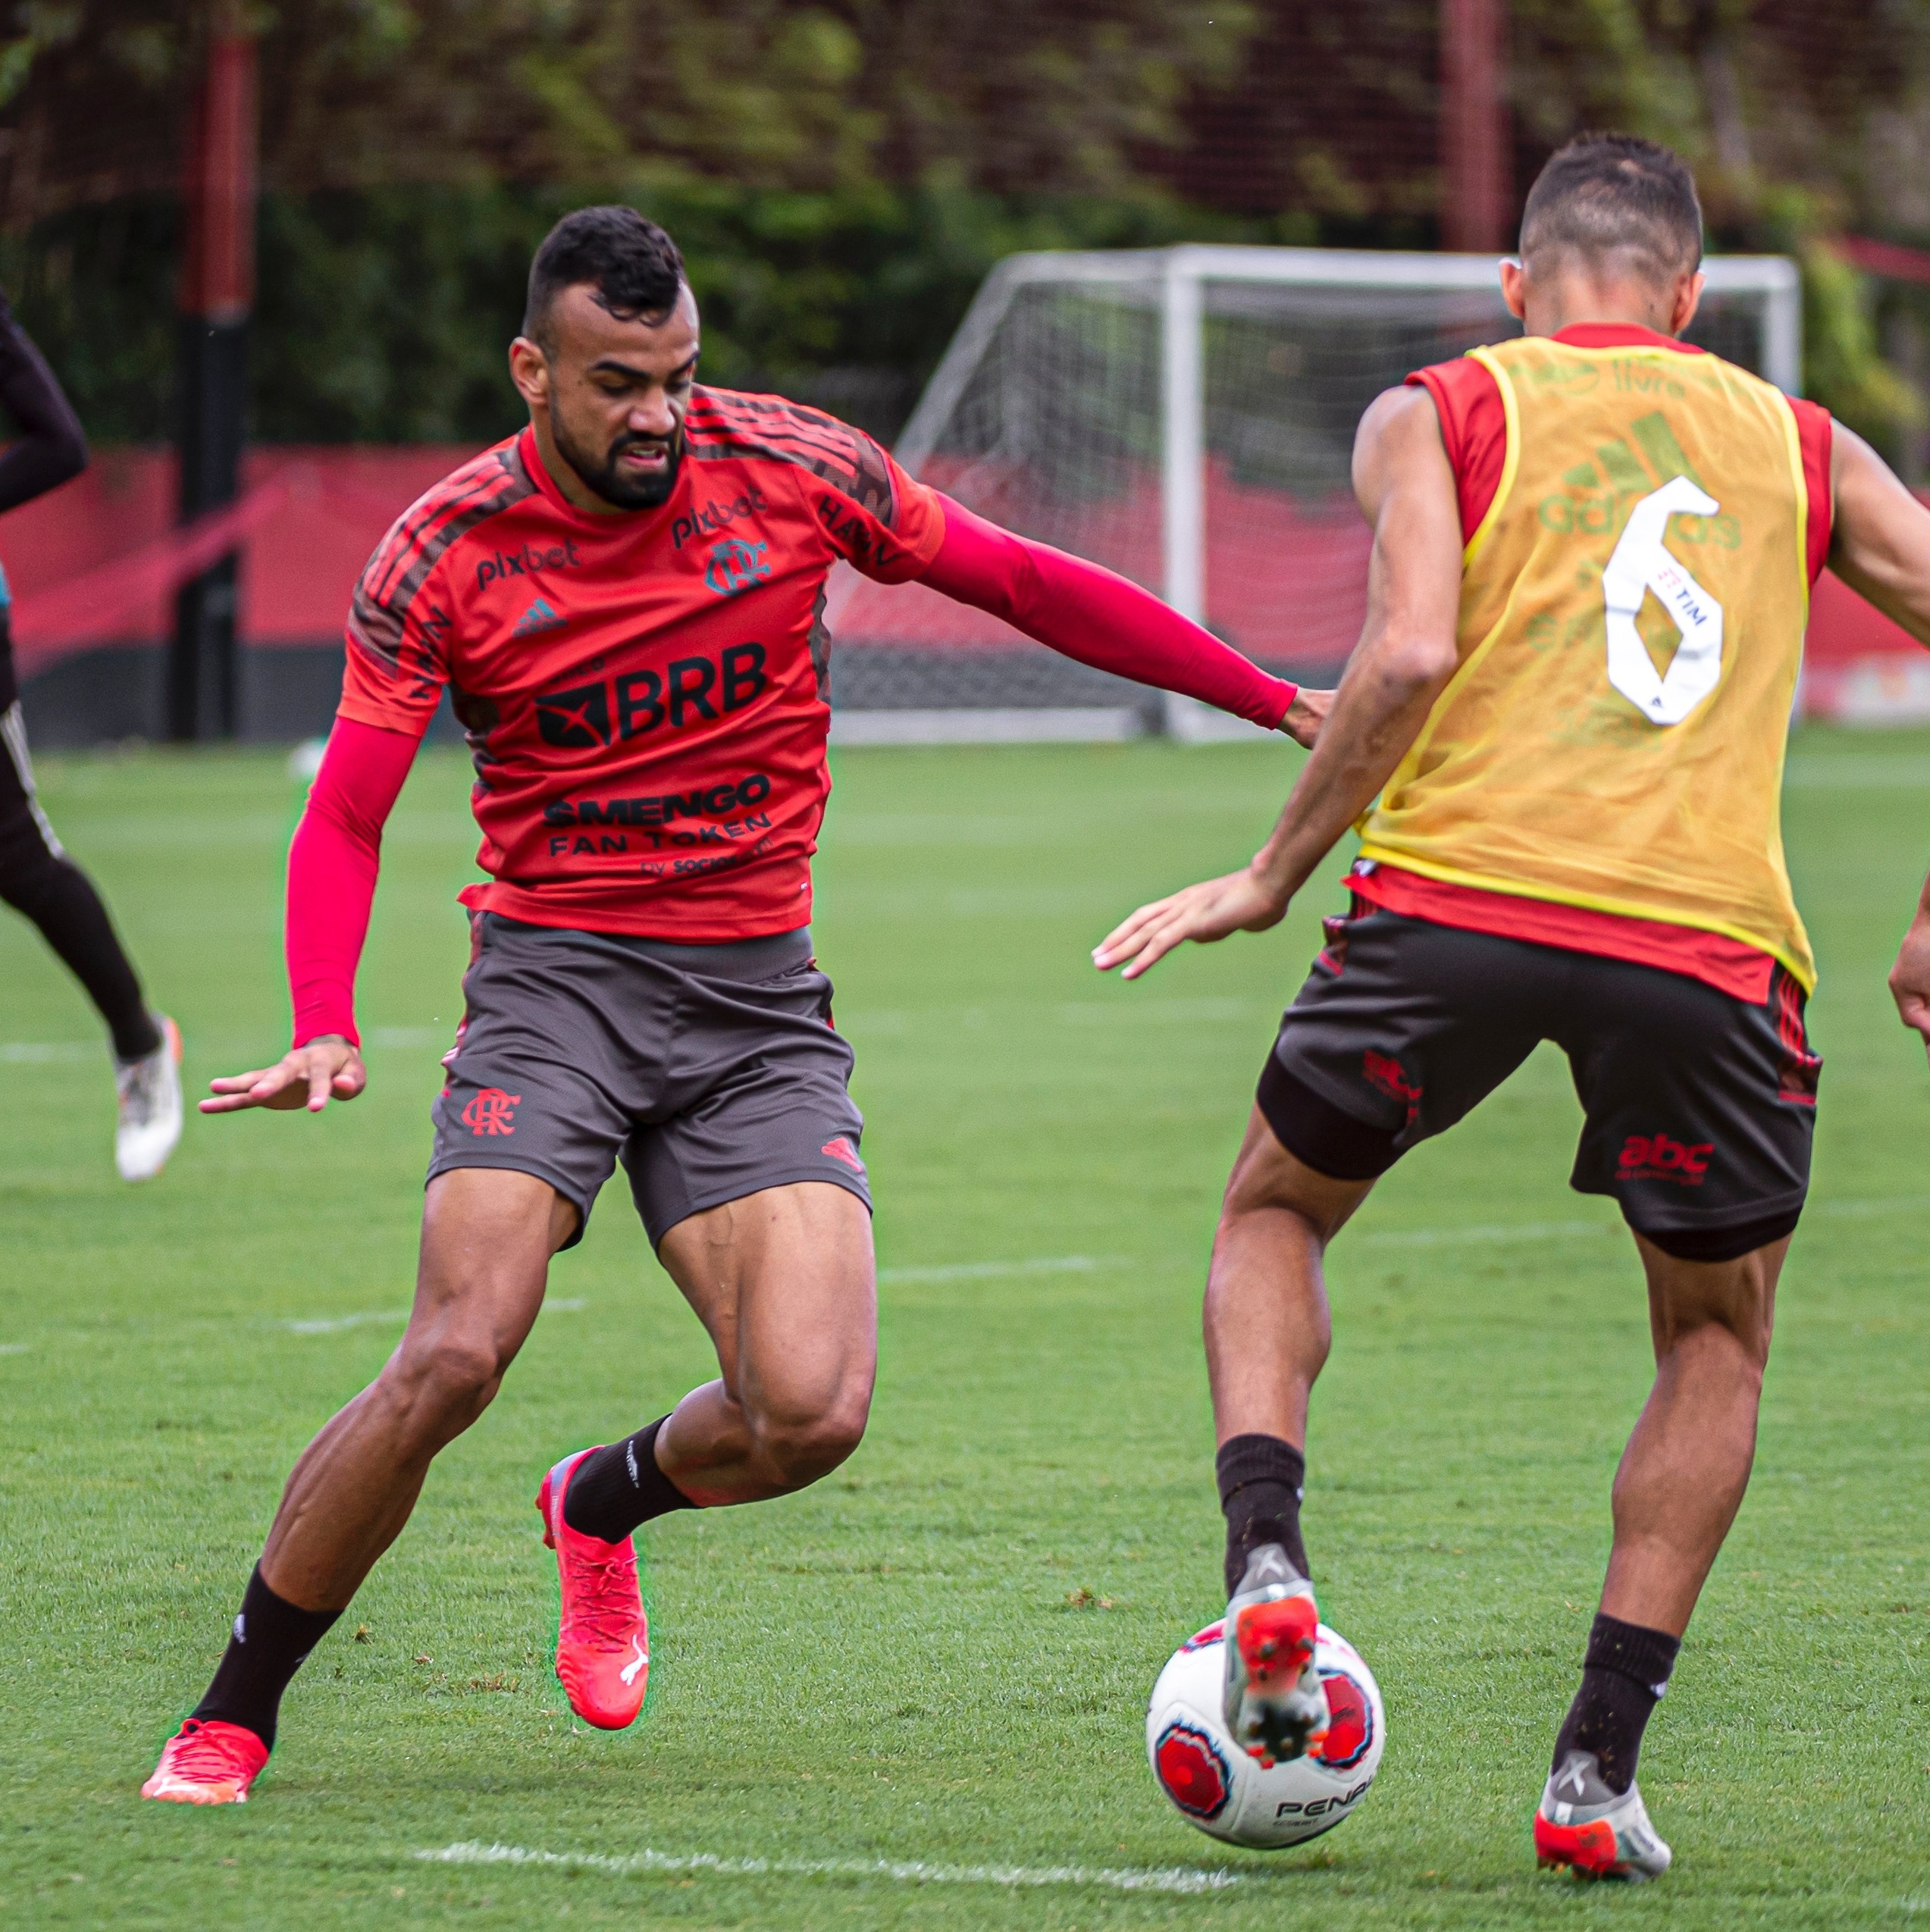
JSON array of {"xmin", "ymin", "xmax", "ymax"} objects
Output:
[{"xmin": 201, "ymin": 719, "xmax": 419, "ymax": 1113}]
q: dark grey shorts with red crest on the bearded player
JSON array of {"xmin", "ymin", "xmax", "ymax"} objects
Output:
[{"xmin": 429, "ymin": 912, "xmax": 871, "ymax": 1246}]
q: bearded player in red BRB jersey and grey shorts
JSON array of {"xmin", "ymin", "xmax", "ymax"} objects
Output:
[{"xmin": 143, "ymin": 208, "xmax": 1325, "ymax": 1805}]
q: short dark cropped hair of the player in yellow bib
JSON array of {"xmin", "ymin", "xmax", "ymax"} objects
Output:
[{"xmin": 1521, "ymin": 133, "xmax": 1702, "ymax": 280}]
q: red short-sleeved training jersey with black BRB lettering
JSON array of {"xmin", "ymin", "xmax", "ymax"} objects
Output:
[{"xmin": 342, "ymin": 387, "xmax": 945, "ymax": 938}]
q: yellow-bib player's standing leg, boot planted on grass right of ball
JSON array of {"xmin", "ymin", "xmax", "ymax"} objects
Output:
[{"xmin": 1534, "ymin": 1235, "xmax": 1789, "ymax": 1878}]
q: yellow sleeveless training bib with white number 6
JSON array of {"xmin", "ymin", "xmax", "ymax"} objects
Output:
[{"xmin": 1362, "ymin": 337, "xmax": 1816, "ymax": 989}]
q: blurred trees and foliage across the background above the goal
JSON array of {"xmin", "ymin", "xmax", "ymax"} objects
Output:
[{"xmin": 0, "ymin": 0, "xmax": 1930, "ymax": 448}]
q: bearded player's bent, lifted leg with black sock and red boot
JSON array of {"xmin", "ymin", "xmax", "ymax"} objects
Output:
[{"xmin": 537, "ymin": 1180, "xmax": 877, "ymax": 1731}]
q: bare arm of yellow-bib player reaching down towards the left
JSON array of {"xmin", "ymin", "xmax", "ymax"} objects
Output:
[{"xmin": 1092, "ymin": 388, "xmax": 1461, "ymax": 979}]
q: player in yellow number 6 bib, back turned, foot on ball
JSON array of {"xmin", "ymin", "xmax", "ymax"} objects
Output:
[{"xmin": 1093, "ymin": 135, "xmax": 1930, "ymax": 1878}]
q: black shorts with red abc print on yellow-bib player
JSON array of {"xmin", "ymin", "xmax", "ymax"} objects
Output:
[{"xmin": 1260, "ymin": 906, "xmax": 1822, "ymax": 1261}]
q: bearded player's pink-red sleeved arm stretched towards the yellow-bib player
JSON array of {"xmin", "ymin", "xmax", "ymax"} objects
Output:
[{"xmin": 920, "ymin": 496, "xmax": 1333, "ymax": 744}]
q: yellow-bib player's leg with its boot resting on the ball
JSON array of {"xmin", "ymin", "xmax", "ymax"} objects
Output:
[{"xmin": 1205, "ymin": 1107, "xmax": 1374, "ymax": 1764}]
